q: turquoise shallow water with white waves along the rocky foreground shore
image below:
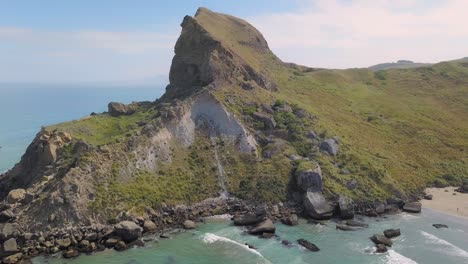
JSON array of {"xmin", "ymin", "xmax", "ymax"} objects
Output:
[{"xmin": 34, "ymin": 210, "xmax": 468, "ymax": 264}]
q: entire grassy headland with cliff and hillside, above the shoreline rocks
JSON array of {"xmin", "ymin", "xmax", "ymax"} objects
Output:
[{"xmin": 0, "ymin": 8, "xmax": 468, "ymax": 260}]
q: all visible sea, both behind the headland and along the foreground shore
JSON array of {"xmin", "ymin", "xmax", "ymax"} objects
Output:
[{"xmin": 0, "ymin": 85, "xmax": 468, "ymax": 264}]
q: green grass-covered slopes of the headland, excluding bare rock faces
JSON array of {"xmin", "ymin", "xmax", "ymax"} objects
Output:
[{"xmin": 42, "ymin": 10, "xmax": 468, "ymax": 214}]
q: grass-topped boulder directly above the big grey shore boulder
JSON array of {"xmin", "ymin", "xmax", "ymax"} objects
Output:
[{"xmin": 296, "ymin": 161, "xmax": 323, "ymax": 192}]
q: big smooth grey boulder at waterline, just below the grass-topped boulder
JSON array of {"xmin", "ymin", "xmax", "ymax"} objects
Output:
[{"xmin": 303, "ymin": 191, "xmax": 334, "ymax": 220}]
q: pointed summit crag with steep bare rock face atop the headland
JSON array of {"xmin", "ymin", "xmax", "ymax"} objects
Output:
[{"xmin": 164, "ymin": 8, "xmax": 276, "ymax": 98}]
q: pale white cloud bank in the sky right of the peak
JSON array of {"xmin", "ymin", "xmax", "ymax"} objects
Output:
[{"xmin": 250, "ymin": 0, "xmax": 468, "ymax": 68}]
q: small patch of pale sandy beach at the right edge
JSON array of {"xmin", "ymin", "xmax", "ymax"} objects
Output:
[{"xmin": 421, "ymin": 187, "xmax": 468, "ymax": 219}]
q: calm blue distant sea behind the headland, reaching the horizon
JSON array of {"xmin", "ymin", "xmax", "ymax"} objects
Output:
[{"xmin": 0, "ymin": 84, "xmax": 164, "ymax": 173}]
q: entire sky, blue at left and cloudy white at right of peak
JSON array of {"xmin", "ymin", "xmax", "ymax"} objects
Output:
[{"xmin": 0, "ymin": 0, "xmax": 468, "ymax": 83}]
